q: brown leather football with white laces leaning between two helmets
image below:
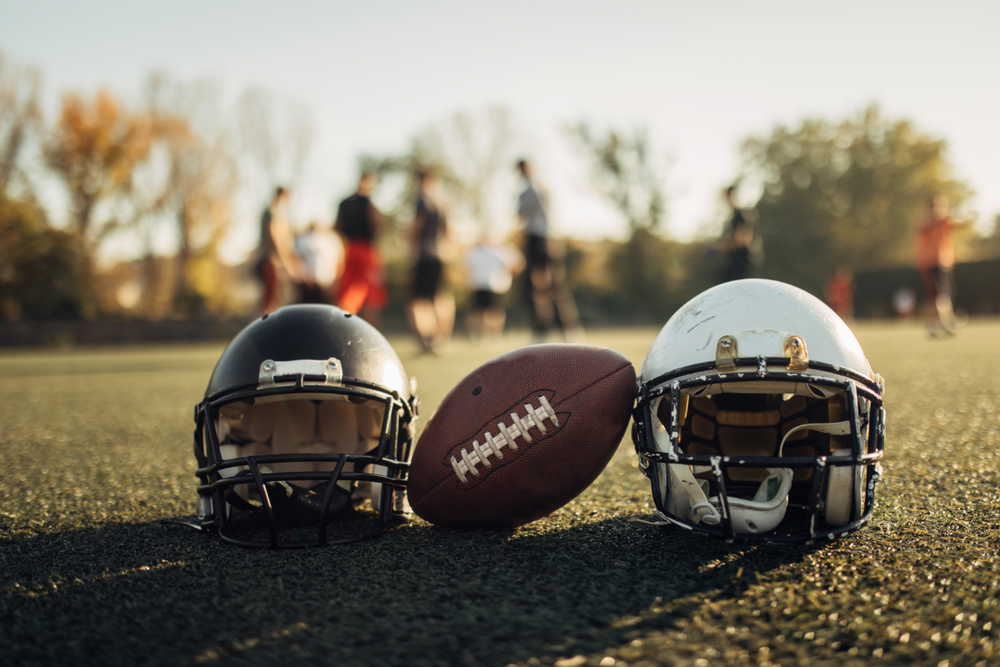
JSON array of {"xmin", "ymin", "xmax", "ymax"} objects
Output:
[{"xmin": 407, "ymin": 344, "xmax": 636, "ymax": 528}]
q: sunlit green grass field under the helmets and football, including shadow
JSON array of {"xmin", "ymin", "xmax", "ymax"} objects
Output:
[{"xmin": 0, "ymin": 320, "xmax": 1000, "ymax": 667}]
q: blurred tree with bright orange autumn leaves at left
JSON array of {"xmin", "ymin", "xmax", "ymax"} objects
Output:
[{"xmin": 45, "ymin": 90, "xmax": 154, "ymax": 247}]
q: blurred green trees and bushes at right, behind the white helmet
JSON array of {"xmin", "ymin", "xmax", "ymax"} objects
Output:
[{"xmin": 570, "ymin": 106, "xmax": 1000, "ymax": 323}]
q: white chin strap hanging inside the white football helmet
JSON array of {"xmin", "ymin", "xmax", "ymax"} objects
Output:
[{"xmin": 657, "ymin": 421, "xmax": 851, "ymax": 534}]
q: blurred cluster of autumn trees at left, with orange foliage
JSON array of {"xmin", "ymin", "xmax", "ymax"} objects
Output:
[{"xmin": 0, "ymin": 53, "xmax": 312, "ymax": 321}]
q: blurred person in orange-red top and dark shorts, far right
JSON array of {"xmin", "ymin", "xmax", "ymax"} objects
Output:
[{"xmin": 916, "ymin": 195, "xmax": 961, "ymax": 336}]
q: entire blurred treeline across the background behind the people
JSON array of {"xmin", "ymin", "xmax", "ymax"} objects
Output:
[{"xmin": 0, "ymin": 49, "xmax": 1000, "ymax": 324}]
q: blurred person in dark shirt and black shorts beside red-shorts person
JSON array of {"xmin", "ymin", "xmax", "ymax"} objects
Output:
[{"xmin": 407, "ymin": 170, "xmax": 455, "ymax": 353}]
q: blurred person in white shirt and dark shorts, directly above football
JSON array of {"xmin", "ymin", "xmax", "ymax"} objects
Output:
[{"xmin": 465, "ymin": 232, "xmax": 524, "ymax": 342}]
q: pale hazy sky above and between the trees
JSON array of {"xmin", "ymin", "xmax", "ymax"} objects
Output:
[{"xmin": 0, "ymin": 0, "xmax": 1000, "ymax": 260}]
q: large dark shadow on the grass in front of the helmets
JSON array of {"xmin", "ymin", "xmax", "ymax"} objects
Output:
[{"xmin": 0, "ymin": 519, "xmax": 808, "ymax": 665}]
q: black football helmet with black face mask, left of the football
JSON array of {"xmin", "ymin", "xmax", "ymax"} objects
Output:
[{"xmin": 194, "ymin": 305, "xmax": 418, "ymax": 548}]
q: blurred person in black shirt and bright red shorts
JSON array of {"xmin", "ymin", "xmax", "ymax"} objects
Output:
[{"xmin": 333, "ymin": 171, "xmax": 388, "ymax": 326}]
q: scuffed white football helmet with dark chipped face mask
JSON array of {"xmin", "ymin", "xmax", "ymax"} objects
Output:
[{"xmin": 632, "ymin": 280, "xmax": 885, "ymax": 542}]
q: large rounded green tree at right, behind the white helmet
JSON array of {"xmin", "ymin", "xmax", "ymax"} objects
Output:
[{"xmin": 742, "ymin": 106, "xmax": 969, "ymax": 294}]
